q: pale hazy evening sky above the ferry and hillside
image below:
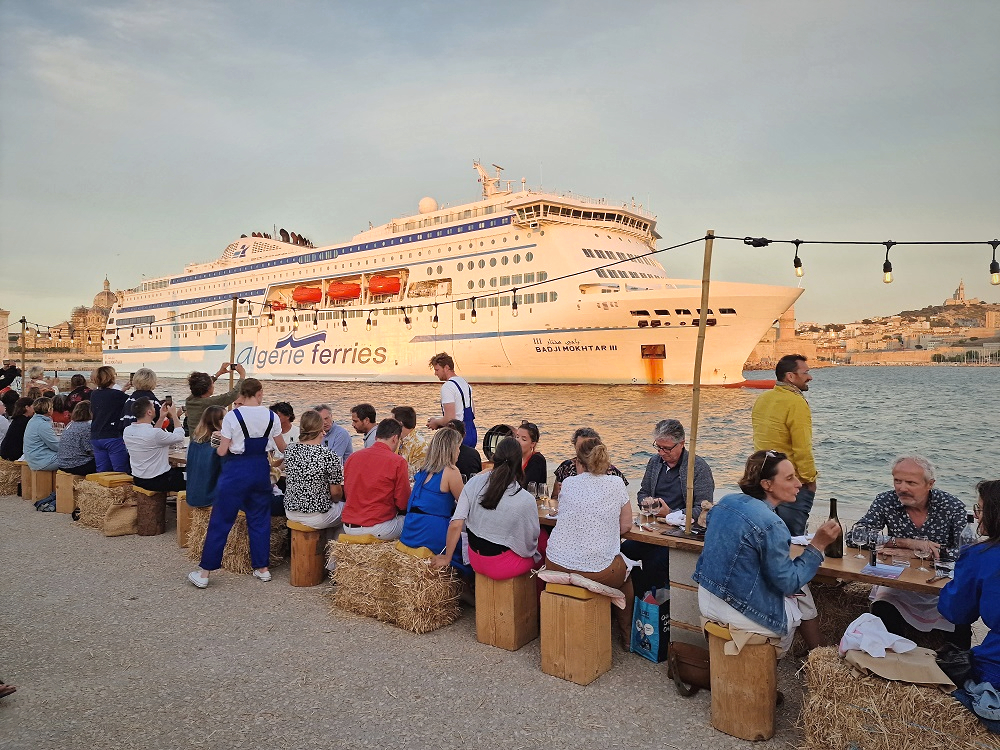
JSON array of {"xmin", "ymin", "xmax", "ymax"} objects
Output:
[{"xmin": 0, "ymin": 0, "xmax": 1000, "ymax": 325}]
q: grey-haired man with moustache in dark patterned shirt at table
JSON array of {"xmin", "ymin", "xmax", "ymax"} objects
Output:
[{"xmin": 858, "ymin": 456, "xmax": 972, "ymax": 649}]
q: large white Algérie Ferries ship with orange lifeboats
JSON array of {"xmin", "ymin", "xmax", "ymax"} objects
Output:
[{"xmin": 104, "ymin": 162, "xmax": 802, "ymax": 384}]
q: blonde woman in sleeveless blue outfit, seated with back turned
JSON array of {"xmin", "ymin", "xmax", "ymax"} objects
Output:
[{"xmin": 399, "ymin": 430, "xmax": 471, "ymax": 573}]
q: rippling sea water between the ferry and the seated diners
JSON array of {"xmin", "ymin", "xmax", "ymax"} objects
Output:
[{"xmin": 146, "ymin": 367, "xmax": 1000, "ymax": 519}]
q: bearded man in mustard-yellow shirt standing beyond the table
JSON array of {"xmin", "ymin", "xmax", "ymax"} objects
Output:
[{"xmin": 751, "ymin": 354, "xmax": 816, "ymax": 536}]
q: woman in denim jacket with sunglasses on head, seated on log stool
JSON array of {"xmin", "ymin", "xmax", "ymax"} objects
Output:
[{"xmin": 694, "ymin": 451, "xmax": 840, "ymax": 655}]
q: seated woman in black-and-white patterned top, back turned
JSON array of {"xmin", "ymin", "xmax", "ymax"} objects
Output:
[{"xmin": 285, "ymin": 410, "xmax": 344, "ymax": 529}]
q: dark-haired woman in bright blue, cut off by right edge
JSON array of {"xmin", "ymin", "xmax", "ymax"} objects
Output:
[{"xmin": 938, "ymin": 479, "xmax": 1000, "ymax": 692}]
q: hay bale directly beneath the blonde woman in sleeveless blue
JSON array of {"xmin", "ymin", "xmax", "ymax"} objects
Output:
[{"xmin": 393, "ymin": 549, "xmax": 462, "ymax": 633}]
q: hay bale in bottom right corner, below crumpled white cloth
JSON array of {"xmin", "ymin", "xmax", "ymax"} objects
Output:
[{"xmin": 800, "ymin": 647, "xmax": 1000, "ymax": 750}]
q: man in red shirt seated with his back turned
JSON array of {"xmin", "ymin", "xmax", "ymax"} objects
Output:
[{"xmin": 341, "ymin": 419, "xmax": 410, "ymax": 539}]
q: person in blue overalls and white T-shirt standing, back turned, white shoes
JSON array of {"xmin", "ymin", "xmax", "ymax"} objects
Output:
[{"xmin": 188, "ymin": 378, "xmax": 285, "ymax": 589}]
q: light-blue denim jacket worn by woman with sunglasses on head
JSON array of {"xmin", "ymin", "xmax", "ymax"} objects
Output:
[{"xmin": 692, "ymin": 493, "xmax": 823, "ymax": 633}]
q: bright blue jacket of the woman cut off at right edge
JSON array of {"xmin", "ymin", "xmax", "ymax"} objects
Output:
[{"xmin": 938, "ymin": 542, "xmax": 1000, "ymax": 685}]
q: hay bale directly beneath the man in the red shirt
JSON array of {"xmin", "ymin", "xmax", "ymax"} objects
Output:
[{"xmin": 327, "ymin": 541, "xmax": 398, "ymax": 622}]
